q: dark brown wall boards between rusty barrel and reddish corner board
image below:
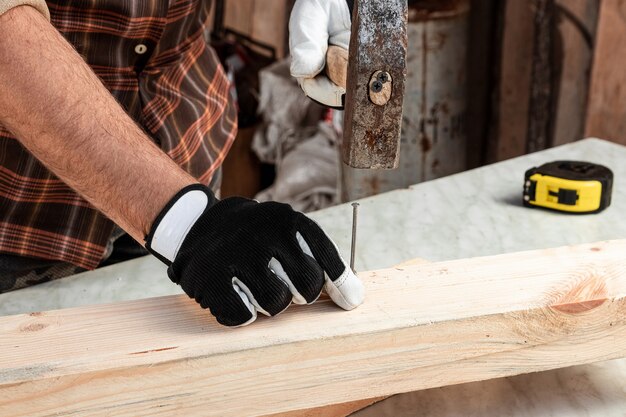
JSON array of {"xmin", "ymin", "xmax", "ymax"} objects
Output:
[{"xmin": 485, "ymin": 0, "xmax": 596, "ymax": 162}]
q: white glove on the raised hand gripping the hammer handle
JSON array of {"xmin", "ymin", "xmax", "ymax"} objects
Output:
[{"xmin": 289, "ymin": 0, "xmax": 351, "ymax": 107}]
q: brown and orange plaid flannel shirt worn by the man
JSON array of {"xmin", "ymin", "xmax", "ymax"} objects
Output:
[{"xmin": 0, "ymin": 0, "xmax": 236, "ymax": 269}]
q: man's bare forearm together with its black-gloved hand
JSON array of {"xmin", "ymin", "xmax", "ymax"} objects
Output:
[{"xmin": 0, "ymin": 6, "xmax": 364, "ymax": 326}]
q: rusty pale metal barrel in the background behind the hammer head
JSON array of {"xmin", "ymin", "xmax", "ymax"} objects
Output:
[{"xmin": 340, "ymin": 0, "xmax": 470, "ymax": 201}]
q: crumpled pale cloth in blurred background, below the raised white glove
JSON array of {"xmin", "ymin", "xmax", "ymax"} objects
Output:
[{"xmin": 252, "ymin": 60, "xmax": 340, "ymax": 212}]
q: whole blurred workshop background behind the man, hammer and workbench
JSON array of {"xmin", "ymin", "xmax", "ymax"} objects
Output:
[{"xmin": 207, "ymin": 0, "xmax": 626, "ymax": 206}]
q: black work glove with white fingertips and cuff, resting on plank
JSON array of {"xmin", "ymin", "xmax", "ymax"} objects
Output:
[{"xmin": 146, "ymin": 185, "xmax": 363, "ymax": 326}]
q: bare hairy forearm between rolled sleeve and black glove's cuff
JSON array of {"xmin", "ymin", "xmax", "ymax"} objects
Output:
[{"xmin": 0, "ymin": 6, "xmax": 196, "ymax": 242}]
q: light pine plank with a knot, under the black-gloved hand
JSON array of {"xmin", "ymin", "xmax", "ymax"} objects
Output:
[{"xmin": 0, "ymin": 240, "xmax": 626, "ymax": 417}]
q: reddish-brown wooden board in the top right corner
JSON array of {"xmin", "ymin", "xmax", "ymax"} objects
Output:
[{"xmin": 585, "ymin": 0, "xmax": 626, "ymax": 144}]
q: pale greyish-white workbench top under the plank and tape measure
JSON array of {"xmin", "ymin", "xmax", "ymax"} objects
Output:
[{"xmin": 0, "ymin": 139, "xmax": 626, "ymax": 417}]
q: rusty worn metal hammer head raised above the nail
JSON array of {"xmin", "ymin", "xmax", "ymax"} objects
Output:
[{"xmin": 343, "ymin": 0, "xmax": 408, "ymax": 169}]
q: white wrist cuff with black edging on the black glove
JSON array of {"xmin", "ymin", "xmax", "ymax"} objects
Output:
[{"xmin": 145, "ymin": 184, "xmax": 217, "ymax": 266}]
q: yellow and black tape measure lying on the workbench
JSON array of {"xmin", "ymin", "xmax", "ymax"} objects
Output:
[{"xmin": 524, "ymin": 161, "xmax": 613, "ymax": 213}]
